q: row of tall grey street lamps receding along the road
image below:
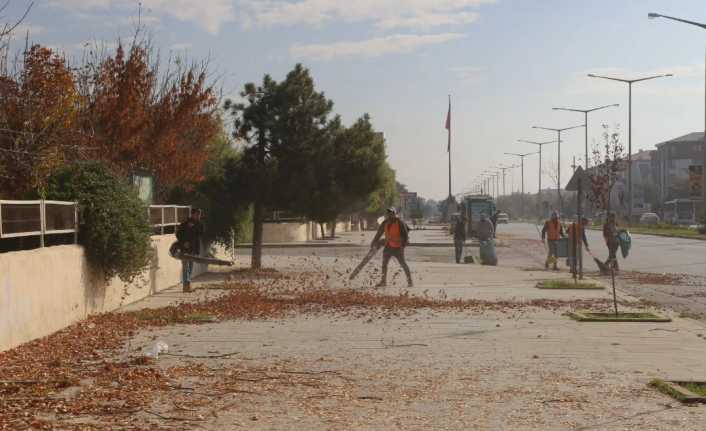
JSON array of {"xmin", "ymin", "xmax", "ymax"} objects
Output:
[{"xmin": 464, "ymin": 13, "xmax": 706, "ymax": 219}]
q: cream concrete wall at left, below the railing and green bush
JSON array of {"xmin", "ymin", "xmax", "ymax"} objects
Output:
[{"xmin": 0, "ymin": 235, "xmax": 205, "ymax": 351}]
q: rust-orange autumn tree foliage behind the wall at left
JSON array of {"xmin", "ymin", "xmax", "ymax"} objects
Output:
[{"xmin": 0, "ymin": 39, "xmax": 222, "ymax": 197}]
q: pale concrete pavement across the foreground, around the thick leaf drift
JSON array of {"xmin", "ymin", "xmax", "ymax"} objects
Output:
[{"xmin": 118, "ymin": 257, "xmax": 706, "ymax": 430}]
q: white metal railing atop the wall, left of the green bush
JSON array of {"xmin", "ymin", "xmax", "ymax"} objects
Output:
[{"xmin": 0, "ymin": 200, "xmax": 78, "ymax": 247}]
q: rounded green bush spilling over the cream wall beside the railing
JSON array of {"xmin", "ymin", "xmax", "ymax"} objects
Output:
[{"xmin": 46, "ymin": 162, "xmax": 151, "ymax": 282}]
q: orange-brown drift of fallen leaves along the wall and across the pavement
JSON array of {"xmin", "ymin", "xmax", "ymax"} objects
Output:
[{"xmin": 0, "ymin": 272, "xmax": 636, "ymax": 430}]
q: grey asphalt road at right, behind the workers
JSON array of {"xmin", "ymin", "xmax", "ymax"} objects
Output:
[{"xmin": 498, "ymin": 223, "xmax": 706, "ymax": 277}]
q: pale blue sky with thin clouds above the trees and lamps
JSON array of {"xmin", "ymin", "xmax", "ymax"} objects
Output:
[{"xmin": 9, "ymin": 0, "xmax": 706, "ymax": 199}]
